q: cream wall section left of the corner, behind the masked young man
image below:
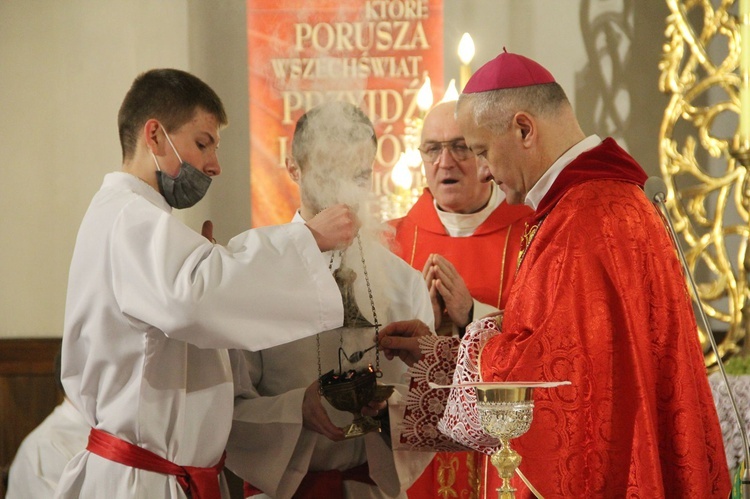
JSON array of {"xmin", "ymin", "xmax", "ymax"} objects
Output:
[{"xmin": 0, "ymin": 0, "xmax": 194, "ymax": 336}]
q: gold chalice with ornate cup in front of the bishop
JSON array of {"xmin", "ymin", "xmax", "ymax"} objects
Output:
[{"xmin": 476, "ymin": 385, "xmax": 534, "ymax": 499}]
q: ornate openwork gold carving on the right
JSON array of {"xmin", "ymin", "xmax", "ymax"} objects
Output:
[{"xmin": 659, "ymin": 0, "xmax": 750, "ymax": 367}]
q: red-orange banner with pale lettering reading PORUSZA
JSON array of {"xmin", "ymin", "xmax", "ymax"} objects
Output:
[{"xmin": 247, "ymin": 0, "xmax": 443, "ymax": 227}]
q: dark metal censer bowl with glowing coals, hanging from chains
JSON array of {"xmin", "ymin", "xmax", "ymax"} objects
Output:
[{"xmin": 320, "ymin": 366, "xmax": 394, "ymax": 438}]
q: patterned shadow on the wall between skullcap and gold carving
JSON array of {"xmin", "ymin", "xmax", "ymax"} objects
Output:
[{"xmin": 575, "ymin": 0, "xmax": 669, "ymax": 175}]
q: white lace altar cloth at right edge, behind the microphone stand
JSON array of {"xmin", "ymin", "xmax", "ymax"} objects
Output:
[{"xmin": 708, "ymin": 372, "xmax": 750, "ymax": 470}]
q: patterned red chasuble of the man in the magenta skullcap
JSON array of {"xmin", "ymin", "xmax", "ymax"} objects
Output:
[{"xmin": 481, "ymin": 139, "xmax": 730, "ymax": 498}]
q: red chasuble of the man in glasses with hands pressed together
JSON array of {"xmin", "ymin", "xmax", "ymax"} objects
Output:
[{"xmin": 391, "ymin": 194, "xmax": 532, "ymax": 499}]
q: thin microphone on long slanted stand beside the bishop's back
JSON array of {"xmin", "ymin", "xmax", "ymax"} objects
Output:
[{"xmin": 643, "ymin": 177, "xmax": 750, "ymax": 499}]
